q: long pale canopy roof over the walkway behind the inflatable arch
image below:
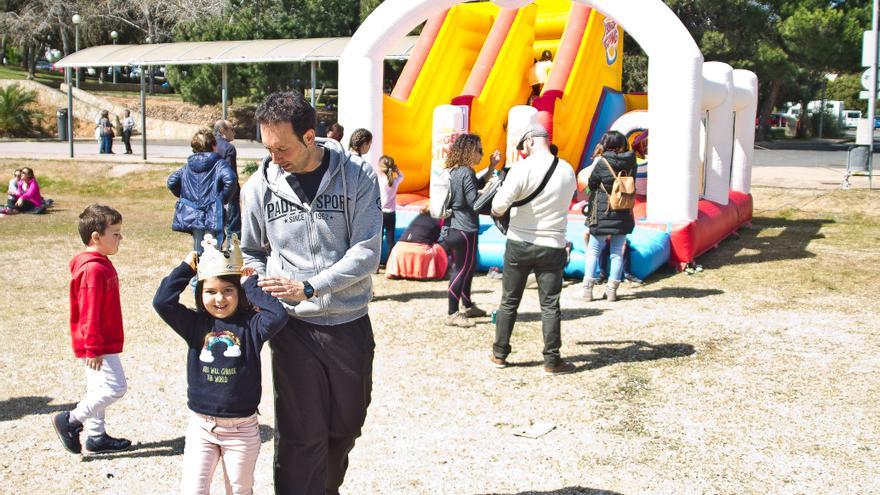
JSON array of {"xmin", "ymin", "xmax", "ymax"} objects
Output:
[{"xmin": 55, "ymin": 36, "xmax": 419, "ymax": 68}]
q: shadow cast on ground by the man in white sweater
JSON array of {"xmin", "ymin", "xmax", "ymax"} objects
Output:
[{"xmin": 510, "ymin": 340, "xmax": 696, "ymax": 373}]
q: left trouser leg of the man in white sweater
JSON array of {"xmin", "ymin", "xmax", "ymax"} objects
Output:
[{"xmin": 492, "ymin": 240, "xmax": 532, "ymax": 359}]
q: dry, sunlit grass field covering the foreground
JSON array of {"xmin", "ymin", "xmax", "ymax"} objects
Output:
[{"xmin": 0, "ymin": 159, "xmax": 880, "ymax": 495}]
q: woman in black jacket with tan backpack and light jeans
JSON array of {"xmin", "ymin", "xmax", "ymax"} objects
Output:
[{"xmin": 582, "ymin": 131, "xmax": 636, "ymax": 301}]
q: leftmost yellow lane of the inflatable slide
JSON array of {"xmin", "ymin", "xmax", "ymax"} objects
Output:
[{"xmin": 383, "ymin": 2, "xmax": 498, "ymax": 193}]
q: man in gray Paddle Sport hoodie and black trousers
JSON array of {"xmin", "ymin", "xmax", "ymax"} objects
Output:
[{"xmin": 241, "ymin": 93, "xmax": 382, "ymax": 494}]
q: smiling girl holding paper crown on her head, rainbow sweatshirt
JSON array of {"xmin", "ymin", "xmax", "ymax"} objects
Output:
[{"xmin": 153, "ymin": 234, "xmax": 288, "ymax": 494}]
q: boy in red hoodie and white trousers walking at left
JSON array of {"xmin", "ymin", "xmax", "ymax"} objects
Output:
[{"xmin": 52, "ymin": 205, "xmax": 131, "ymax": 454}]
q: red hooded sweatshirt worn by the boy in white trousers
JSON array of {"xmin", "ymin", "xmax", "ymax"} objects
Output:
[{"xmin": 70, "ymin": 251, "xmax": 124, "ymax": 358}]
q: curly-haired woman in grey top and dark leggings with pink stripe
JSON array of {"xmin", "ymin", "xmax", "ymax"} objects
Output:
[{"xmin": 445, "ymin": 134, "xmax": 501, "ymax": 327}]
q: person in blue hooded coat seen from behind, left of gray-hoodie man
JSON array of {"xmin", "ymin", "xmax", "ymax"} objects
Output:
[{"xmin": 168, "ymin": 129, "xmax": 237, "ymax": 254}]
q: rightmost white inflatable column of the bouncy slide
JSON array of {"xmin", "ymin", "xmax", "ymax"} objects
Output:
[{"xmin": 730, "ymin": 69, "xmax": 758, "ymax": 194}]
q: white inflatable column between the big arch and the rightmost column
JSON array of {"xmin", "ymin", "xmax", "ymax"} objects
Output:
[{"xmin": 703, "ymin": 62, "xmax": 733, "ymax": 205}]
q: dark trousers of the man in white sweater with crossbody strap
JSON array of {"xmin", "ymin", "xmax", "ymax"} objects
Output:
[{"xmin": 492, "ymin": 239, "xmax": 565, "ymax": 367}]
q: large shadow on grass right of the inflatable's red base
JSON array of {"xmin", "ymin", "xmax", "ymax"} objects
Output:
[{"xmin": 699, "ymin": 217, "xmax": 834, "ymax": 268}]
